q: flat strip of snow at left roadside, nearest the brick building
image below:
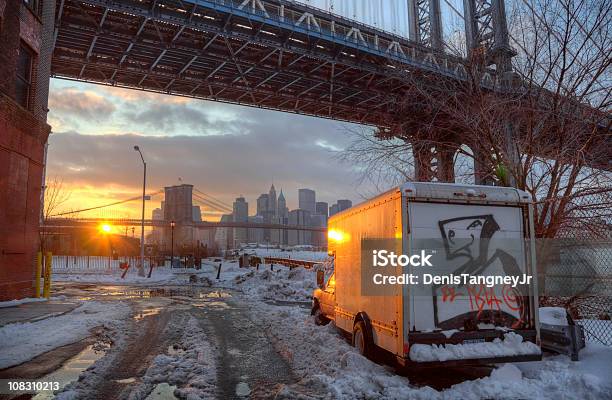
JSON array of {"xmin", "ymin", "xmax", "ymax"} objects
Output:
[{"xmin": 0, "ymin": 301, "xmax": 130, "ymax": 369}]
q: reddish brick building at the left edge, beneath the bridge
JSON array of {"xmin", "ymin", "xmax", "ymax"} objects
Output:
[{"xmin": 0, "ymin": 0, "xmax": 55, "ymax": 301}]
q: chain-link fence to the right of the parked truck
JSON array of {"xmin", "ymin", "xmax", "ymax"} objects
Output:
[{"xmin": 537, "ymin": 194, "xmax": 612, "ymax": 346}]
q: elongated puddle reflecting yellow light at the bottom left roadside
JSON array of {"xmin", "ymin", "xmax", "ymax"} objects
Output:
[{"xmin": 32, "ymin": 344, "xmax": 106, "ymax": 400}]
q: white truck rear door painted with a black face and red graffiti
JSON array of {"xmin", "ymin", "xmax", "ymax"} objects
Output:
[{"xmin": 407, "ymin": 201, "xmax": 531, "ymax": 332}]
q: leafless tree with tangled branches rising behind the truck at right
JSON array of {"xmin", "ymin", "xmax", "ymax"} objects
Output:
[{"xmin": 343, "ymin": 0, "xmax": 612, "ymax": 238}]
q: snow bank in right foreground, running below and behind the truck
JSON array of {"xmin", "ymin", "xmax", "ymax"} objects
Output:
[{"xmin": 252, "ymin": 303, "xmax": 612, "ymax": 400}]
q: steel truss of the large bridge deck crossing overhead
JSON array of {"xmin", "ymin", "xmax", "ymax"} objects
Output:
[{"xmin": 52, "ymin": 0, "xmax": 506, "ymax": 125}]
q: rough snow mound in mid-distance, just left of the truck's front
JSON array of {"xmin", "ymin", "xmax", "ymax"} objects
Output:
[{"xmin": 234, "ymin": 266, "xmax": 317, "ymax": 301}]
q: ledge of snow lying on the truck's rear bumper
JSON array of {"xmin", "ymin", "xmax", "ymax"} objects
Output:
[{"xmin": 410, "ymin": 332, "xmax": 541, "ymax": 362}]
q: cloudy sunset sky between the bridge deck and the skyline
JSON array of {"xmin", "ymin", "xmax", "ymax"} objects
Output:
[{"xmin": 47, "ymin": 79, "xmax": 378, "ymax": 219}]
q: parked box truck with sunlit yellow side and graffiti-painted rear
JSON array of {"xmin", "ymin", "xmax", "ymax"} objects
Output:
[{"xmin": 312, "ymin": 182, "xmax": 541, "ymax": 365}]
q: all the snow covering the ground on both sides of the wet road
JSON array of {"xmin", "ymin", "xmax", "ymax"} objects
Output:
[{"xmin": 10, "ymin": 255, "xmax": 612, "ymax": 400}]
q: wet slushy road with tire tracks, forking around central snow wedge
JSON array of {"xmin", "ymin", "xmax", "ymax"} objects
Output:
[{"xmin": 40, "ymin": 284, "xmax": 296, "ymax": 399}]
